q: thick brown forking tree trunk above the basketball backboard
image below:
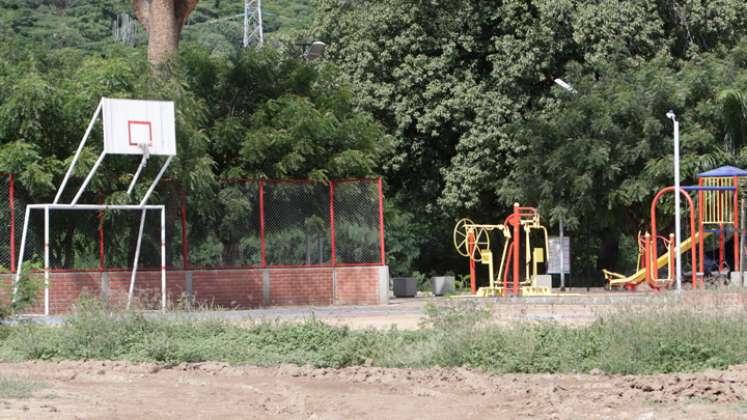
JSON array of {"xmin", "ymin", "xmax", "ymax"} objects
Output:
[{"xmin": 130, "ymin": 0, "xmax": 199, "ymax": 65}]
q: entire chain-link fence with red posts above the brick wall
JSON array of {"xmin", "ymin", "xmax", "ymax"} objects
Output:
[{"xmin": 0, "ymin": 175, "xmax": 384, "ymax": 271}]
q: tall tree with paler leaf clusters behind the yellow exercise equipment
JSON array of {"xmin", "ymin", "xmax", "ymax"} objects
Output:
[{"xmin": 317, "ymin": 0, "xmax": 747, "ymax": 278}]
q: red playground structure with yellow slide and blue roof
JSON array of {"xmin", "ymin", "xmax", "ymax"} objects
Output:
[{"xmin": 602, "ymin": 166, "xmax": 747, "ymax": 290}]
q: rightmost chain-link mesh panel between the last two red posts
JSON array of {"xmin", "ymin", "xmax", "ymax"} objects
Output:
[{"xmin": 334, "ymin": 180, "xmax": 381, "ymax": 264}]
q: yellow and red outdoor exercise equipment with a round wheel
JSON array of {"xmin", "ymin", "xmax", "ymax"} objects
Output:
[{"xmin": 453, "ymin": 203, "xmax": 551, "ymax": 296}]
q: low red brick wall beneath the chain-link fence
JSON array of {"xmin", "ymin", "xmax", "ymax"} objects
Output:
[{"xmin": 5, "ymin": 266, "xmax": 387, "ymax": 314}]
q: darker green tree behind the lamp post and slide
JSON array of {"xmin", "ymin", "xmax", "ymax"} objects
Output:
[{"xmin": 502, "ymin": 43, "xmax": 747, "ymax": 278}]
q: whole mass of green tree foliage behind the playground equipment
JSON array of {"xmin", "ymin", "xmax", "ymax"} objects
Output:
[{"xmin": 317, "ymin": 0, "xmax": 747, "ymax": 279}]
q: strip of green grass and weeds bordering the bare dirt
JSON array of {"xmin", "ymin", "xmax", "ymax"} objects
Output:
[{"xmin": 0, "ymin": 300, "xmax": 747, "ymax": 374}]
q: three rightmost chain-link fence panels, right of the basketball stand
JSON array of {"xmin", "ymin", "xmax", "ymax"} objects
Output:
[{"xmin": 185, "ymin": 179, "xmax": 384, "ymax": 268}]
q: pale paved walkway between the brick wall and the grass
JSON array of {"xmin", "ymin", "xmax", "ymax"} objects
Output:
[{"xmin": 10, "ymin": 289, "xmax": 747, "ymax": 329}]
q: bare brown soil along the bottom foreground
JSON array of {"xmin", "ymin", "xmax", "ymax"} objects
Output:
[{"xmin": 0, "ymin": 361, "xmax": 747, "ymax": 419}]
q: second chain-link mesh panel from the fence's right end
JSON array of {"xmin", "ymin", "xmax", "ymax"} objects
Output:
[{"xmin": 264, "ymin": 182, "xmax": 331, "ymax": 265}]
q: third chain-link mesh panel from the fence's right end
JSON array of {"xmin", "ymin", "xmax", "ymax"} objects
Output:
[{"xmin": 187, "ymin": 181, "xmax": 262, "ymax": 267}]
